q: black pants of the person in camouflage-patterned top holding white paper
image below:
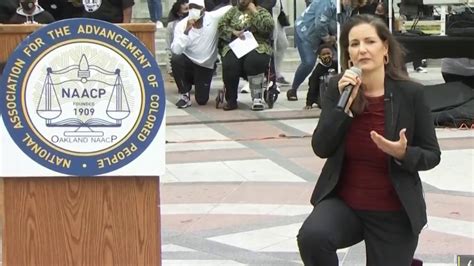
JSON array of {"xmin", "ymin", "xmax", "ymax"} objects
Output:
[{"xmin": 222, "ymin": 50, "xmax": 270, "ymax": 104}]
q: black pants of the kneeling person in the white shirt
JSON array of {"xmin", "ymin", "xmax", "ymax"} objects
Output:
[{"xmin": 171, "ymin": 54, "xmax": 214, "ymax": 105}]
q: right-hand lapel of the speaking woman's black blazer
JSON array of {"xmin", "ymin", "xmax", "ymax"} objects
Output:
[{"xmin": 384, "ymin": 77, "xmax": 400, "ymax": 140}]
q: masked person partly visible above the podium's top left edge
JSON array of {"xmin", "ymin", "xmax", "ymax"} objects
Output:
[{"xmin": 9, "ymin": 0, "xmax": 54, "ymax": 24}]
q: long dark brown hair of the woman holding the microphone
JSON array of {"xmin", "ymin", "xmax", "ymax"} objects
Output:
[{"xmin": 340, "ymin": 14, "xmax": 409, "ymax": 80}]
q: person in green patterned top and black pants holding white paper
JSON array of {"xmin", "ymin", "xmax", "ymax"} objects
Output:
[{"xmin": 218, "ymin": 0, "xmax": 274, "ymax": 111}]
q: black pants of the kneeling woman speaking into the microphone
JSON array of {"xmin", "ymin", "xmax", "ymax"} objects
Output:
[{"xmin": 297, "ymin": 197, "xmax": 418, "ymax": 266}]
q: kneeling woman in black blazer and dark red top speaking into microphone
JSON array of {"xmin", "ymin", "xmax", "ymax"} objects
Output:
[{"xmin": 297, "ymin": 15, "xmax": 441, "ymax": 266}]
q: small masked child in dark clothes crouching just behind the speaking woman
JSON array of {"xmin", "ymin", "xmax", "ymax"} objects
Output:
[{"xmin": 304, "ymin": 44, "xmax": 337, "ymax": 109}]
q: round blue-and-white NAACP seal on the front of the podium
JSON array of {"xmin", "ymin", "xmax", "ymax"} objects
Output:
[{"xmin": 1, "ymin": 19, "xmax": 165, "ymax": 175}]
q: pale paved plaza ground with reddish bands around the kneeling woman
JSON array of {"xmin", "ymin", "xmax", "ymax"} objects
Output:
[{"xmin": 161, "ymin": 67, "xmax": 474, "ymax": 266}]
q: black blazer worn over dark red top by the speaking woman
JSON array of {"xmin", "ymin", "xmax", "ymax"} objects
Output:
[{"xmin": 311, "ymin": 75, "xmax": 441, "ymax": 235}]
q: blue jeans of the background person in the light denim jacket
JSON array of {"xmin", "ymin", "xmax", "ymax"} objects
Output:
[{"xmin": 291, "ymin": 31, "xmax": 316, "ymax": 90}]
